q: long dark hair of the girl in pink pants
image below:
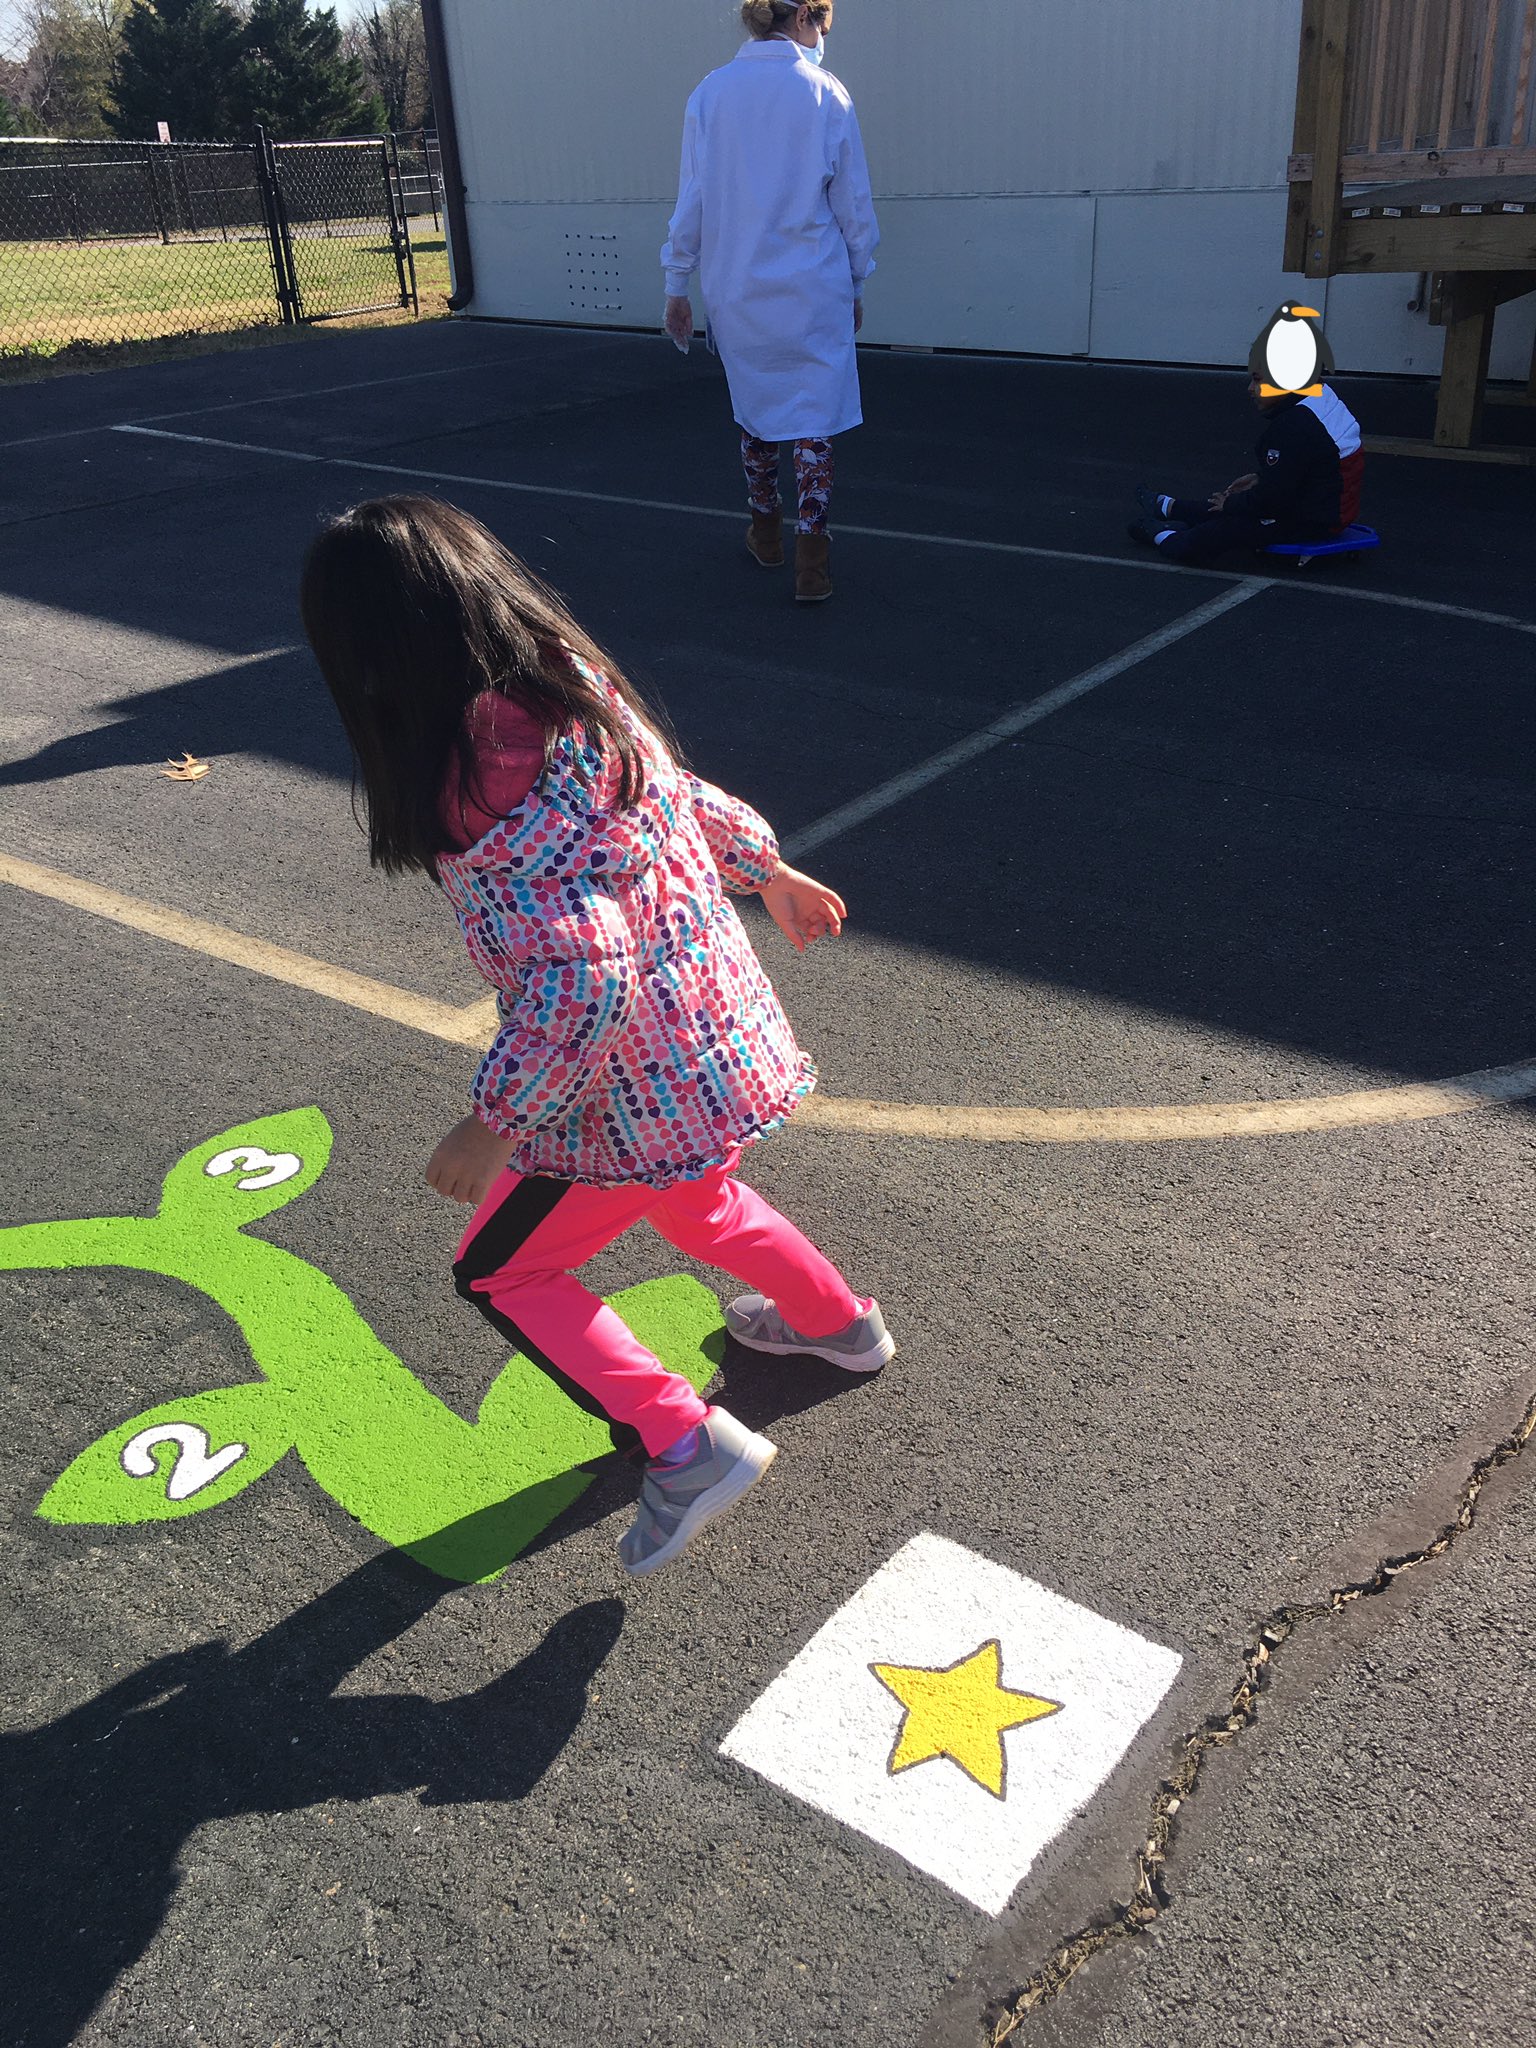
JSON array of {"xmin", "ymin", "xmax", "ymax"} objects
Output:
[{"xmin": 299, "ymin": 496, "xmax": 670, "ymax": 874}]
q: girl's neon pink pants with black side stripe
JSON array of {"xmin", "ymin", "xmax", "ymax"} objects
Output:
[{"xmin": 453, "ymin": 1153, "xmax": 866, "ymax": 1456}]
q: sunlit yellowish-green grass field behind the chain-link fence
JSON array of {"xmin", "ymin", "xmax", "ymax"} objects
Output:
[{"xmin": 0, "ymin": 236, "xmax": 449, "ymax": 373}]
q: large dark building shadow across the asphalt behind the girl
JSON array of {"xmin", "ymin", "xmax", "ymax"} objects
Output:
[{"xmin": 0, "ymin": 338, "xmax": 1536, "ymax": 1096}]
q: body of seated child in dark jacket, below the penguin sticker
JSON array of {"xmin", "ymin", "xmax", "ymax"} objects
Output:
[{"xmin": 1128, "ymin": 377, "xmax": 1366, "ymax": 561}]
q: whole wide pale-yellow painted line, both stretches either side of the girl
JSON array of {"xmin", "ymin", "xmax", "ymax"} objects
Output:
[{"xmin": 0, "ymin": 854, "xmax": 1536, "ymax": 1145}]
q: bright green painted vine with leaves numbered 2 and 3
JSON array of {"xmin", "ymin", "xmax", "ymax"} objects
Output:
[{"xmin": 0, "ymin": 1108, "xmax": 725, "ymax": 1583}]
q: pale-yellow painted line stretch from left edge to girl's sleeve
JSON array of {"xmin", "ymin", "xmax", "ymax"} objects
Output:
[{"xmin": 0, "ymin": 854, "xmax": 494, "ymax": 1044}]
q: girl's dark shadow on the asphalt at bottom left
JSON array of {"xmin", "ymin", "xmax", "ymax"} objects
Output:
[{"xmin": 0, "ymin": 1554, "xmax": 625, "ymax": 2048}]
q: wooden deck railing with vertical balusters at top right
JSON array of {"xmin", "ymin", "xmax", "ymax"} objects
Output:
[{"xmin": 1290, "ymin": 0, "xmax": 1536, "ymax": 184}]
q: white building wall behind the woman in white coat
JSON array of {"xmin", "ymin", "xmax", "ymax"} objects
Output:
[{"xmin": 444, "ymin": 0, "xmax": 1536, "ymax": 377}]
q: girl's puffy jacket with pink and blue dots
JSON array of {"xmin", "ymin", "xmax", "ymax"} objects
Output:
[{"xmin": 438, "ymin": 663, "xmax": 815, "ymax": 1188}]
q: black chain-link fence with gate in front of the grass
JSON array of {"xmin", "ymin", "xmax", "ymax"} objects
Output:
[{"xmin": 0, "ymin": 135, "xmax": 424, "ymax": 373}]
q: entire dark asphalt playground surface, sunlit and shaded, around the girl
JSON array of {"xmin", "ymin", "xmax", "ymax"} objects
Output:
[{"xmin": 0, "ymin": 324, "xmax": 1536, "ymax": 2048}]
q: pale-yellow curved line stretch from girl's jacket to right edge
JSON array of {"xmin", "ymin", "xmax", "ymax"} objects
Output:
[{"xmin": 795, "ymin": 1059, "xmax": 1536, "ymax": 1145}]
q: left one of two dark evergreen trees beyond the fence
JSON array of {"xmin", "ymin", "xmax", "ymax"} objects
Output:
[{"xmin": 106, "ymin": 0, "xmax": 244, "ymax": 141}]
